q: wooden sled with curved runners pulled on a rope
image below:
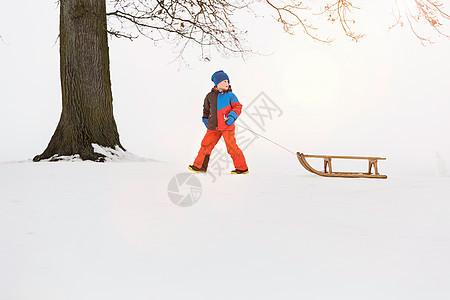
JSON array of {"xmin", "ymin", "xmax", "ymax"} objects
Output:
[{"xmin": 297, "ymin": 152, "xmax": 387, "ymax": 179}]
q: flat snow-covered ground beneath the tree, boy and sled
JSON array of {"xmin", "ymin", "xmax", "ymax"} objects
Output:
[{"xmin": 0, "ymin": 157, "xmax": 450, "ymax": 300}]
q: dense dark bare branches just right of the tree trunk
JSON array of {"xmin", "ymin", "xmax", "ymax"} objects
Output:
[{"xmin": 107, "ymin": 0, "xmax": 253, "ymax": 58}]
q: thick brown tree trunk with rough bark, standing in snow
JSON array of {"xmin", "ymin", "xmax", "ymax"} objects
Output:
[{"xmin": 33, "ymin": 0, "xmax": 123, "ymax": 161}]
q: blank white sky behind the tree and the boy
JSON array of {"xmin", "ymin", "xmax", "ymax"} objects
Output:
[{"xmin": 0, "ymin": 0, "xmax": 450, "ymax": 175}]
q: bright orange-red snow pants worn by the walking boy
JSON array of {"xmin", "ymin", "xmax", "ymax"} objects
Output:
[{"xmin": 194, "ymin": 130, "xmax": 248, "ymax": 171}]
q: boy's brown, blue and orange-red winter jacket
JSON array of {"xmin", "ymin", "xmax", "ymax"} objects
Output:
[{"xmin": 203, "ymin": 87, "xmax": 242, "ymax": 131}]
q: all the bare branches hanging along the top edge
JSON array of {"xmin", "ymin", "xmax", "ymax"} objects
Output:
[{"xmin": 102, "ymin": 0, "xmax": 450, "ymax": 60}]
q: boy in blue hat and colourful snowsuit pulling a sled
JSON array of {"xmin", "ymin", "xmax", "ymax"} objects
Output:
[{"xmin": 189, "ymin": 70, "xmax": 248, "ymax": 174}]
